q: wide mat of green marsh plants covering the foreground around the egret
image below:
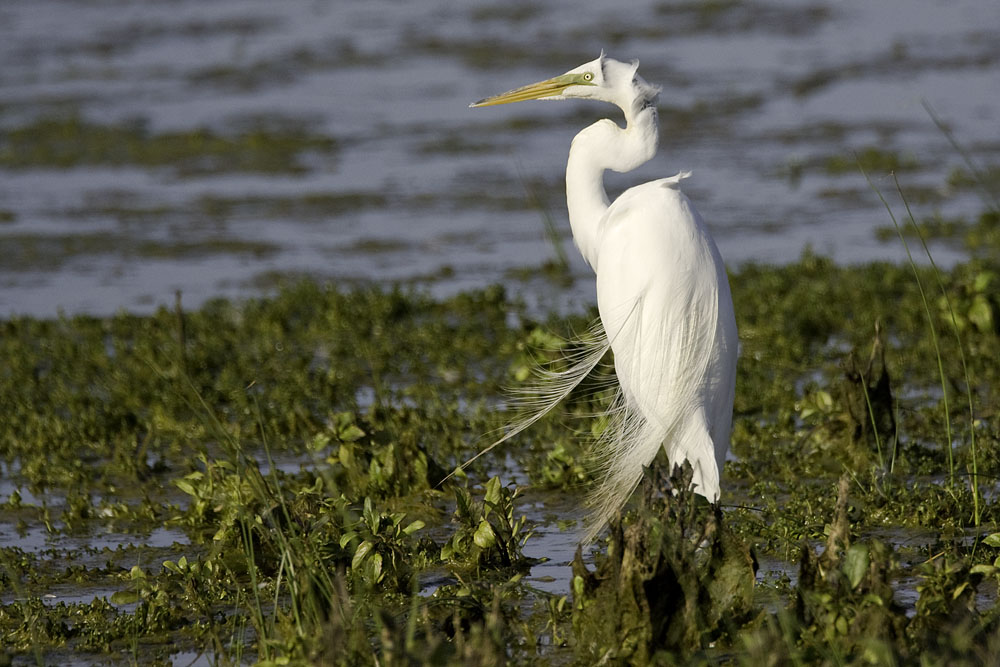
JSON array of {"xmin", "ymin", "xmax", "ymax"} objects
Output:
[{"xmin": 0, "ymin": 213, "xmax": 1000, "ymax": 664}]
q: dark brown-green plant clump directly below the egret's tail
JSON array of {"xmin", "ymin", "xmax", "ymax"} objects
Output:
[{"xmin": 573, "ymin": 464, "xmax": 756, "ymax": 664}]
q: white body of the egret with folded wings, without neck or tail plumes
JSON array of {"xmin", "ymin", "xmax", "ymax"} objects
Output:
[{"xmin": 597, "ymin": 179, "xmax": 732, "ymax": 454}]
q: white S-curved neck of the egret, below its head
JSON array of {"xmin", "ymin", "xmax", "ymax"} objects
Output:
[{"xmin": 566, "ymin": 105, "xmax": 659, "ymax": 272}]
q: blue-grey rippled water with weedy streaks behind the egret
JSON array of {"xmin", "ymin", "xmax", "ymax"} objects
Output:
[{"xmin": 0, "ymin": 0, "xmax": 1000, "ymax": 316}]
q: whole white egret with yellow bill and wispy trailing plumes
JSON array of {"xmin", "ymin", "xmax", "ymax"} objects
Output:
[{"xmin": 470, "ymin": 52, "xmax": 738, "ymax": 541}]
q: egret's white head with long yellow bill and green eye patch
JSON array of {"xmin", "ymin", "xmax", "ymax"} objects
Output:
[{"xmin": 469, "ymin": 51, "xmax": 660, "ymax": 115}]
